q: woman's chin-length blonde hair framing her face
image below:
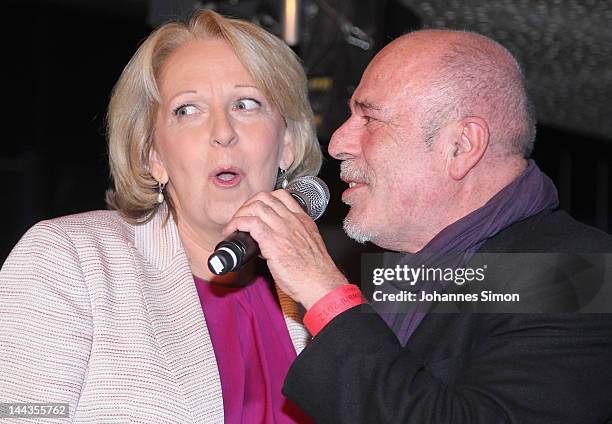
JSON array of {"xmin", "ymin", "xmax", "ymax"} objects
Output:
[{"xmin": 106, "ymin": 10, "xmax": 321, "ymax": 222}]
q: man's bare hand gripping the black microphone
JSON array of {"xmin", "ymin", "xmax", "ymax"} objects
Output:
[{"xmin": 223, "ymin": 190, "xmax": 347, "ymax": 309}]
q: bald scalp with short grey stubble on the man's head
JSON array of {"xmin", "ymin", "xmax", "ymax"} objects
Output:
[{"xmin": 372, "ymin": 30, "xmax": 535, "ymax": 158}]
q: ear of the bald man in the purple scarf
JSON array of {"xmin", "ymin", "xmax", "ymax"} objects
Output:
[{"xmin": 448, "ymin": 116, "xmax": 489, "ymax": 181}]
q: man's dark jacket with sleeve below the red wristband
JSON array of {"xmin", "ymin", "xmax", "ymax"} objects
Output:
[{"xmin": 284, "ymin": 212, "xmax": 612, "ymax": 424}]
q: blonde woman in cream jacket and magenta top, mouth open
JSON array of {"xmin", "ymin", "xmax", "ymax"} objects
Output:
[{"xmin": 0, "ymin": 11, "xmax": 321, "ymax": 423}]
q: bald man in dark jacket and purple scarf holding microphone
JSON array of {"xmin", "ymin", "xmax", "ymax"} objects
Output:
[{"xmin": 226, "ymin": 30, "xmax": 612, "ymax": 424}]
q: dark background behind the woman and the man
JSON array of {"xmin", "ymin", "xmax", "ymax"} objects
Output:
[{"xmin": 0, "ymin": 0, "xmax": 612, "ymax": 280}]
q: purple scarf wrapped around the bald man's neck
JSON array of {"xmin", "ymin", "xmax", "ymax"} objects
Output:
[{"xmin": 381, "ymin": 160, "xmax": 559, "ymax": 345}]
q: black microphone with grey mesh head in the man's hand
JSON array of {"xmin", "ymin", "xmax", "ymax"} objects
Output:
[{"xmin": 208, "ymin": 176, "xmax": 329, "ymax": 275}]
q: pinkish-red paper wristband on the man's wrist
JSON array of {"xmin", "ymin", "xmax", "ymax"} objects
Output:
[{"xmin": 304, "ymin": 284, "xmax": 367, "ymax": 337}]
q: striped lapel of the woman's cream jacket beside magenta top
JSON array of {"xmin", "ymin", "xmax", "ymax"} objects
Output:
[{"xmin": 134, "ymin": 209, "xmax": 223, "ymax": 423}]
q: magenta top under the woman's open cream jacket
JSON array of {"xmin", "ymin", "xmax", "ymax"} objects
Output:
[{"xmin": 194, "ymin": 277, "xmax": 312, "ymax": 424}]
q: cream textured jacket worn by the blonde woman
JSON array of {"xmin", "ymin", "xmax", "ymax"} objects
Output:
[{"xmin": 0, "ymin": 211, "xmax": 309, "ymax": 424}]
